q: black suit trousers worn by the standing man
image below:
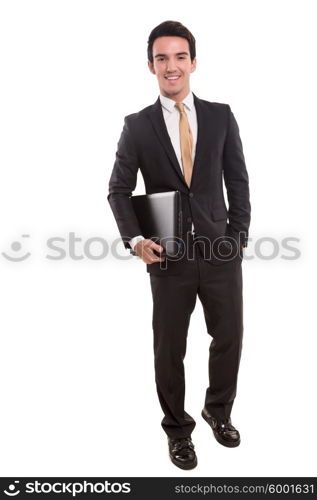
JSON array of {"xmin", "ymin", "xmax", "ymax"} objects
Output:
[{"xmin": 150, "ymin": 231, "xmax": 243, "ymax": 438}]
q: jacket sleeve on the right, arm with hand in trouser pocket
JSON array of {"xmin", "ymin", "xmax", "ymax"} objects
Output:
[{"xmin": 223, "ymin": 105, "xmax": 251, "ymax": 247}]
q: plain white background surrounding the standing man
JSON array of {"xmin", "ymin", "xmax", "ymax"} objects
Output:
[{"xmin": 0, "ymin": 0, "xmax": 317, "ymax": 477}]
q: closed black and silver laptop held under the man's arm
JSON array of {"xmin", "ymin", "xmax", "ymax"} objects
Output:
[{"xmin": 131, "ymin": 191, "xmax": 182, "ymax": 257}]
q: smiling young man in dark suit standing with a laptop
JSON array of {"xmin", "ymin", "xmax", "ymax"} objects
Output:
[{"xmin": 108, "ymin": 21, "xmax": 250, "ymax": 469}]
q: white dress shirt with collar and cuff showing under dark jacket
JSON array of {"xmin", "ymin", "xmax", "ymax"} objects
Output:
[{"xmin": 129, "ymin": 92, "xmax": 198, "ymax": 250}]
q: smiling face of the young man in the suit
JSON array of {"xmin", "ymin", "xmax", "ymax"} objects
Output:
[{"xmin": 148, "ymin": 36, "xmax": 196, "ymax": 102}]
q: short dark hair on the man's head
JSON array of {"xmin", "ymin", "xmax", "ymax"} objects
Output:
[{"xmin": 147, "ymin": 21, "xmax": 196, "ymax": 63}]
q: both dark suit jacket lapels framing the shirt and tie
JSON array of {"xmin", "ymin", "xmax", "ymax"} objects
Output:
[{"xmin": 149, "ymin": 94, "xmax": 207, "ymax": 189}]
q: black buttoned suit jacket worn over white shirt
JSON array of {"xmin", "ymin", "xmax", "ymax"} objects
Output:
[{"xmin": 108, "ymin": 95, "xmax": 251, "ymax": 274}]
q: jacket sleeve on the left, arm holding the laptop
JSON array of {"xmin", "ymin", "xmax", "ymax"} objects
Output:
[{"xmin": 107, "ymin": 117, "xmax": 142, "ymax": 248}]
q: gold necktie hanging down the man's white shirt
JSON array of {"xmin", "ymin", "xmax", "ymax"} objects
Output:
[{"xmin": 175, "ymin": 102, "xmax": 193, "ymax": 187}]
